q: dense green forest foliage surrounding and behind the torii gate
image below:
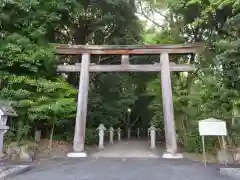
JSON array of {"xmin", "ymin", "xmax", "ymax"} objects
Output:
[{"xmin": 0, "ymin": 0, "xmax": 240, "ymax": 156}]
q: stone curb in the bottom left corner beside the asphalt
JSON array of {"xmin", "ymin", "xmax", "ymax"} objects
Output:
[{"xmin": 0, "ymin": 165, "xmax": 32, "ymax": 180}]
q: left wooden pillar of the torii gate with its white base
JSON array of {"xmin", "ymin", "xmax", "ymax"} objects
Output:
[{"xmin": 68, "ymin": 54, "xmax": 90, "ymax": 157}]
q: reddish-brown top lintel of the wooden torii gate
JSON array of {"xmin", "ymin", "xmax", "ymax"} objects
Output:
[{"xmin": 54, "ymin": 43, "xmax": 204, "ymax": 55}]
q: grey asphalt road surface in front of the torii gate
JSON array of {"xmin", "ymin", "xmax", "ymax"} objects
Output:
[{"xmin": 9, "ymin": 158, "xmax": 231, "ymax": 180}]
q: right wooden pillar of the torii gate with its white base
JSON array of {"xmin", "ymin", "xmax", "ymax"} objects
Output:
[{"xmin": 160, "ymin": 53, "xmax": 183, "ymax": 159}]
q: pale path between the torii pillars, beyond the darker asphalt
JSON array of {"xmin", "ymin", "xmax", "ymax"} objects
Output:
[{"xmin": 91, "ymin": 140, "xmax": 161, "ymax": 158}]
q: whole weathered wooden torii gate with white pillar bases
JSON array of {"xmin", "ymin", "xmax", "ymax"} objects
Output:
[{"xmin": 55, "ymin": 44, "xmax": 203, "ymax": 158}]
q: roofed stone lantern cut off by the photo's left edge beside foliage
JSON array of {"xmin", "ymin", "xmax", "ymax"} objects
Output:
[{"xmin": 0, "ymin": 102, "xmax": 17, "ymax": 156}]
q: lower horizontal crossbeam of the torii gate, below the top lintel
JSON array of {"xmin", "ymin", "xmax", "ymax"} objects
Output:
[{"xmin": 57, "ymin": 63, "xmax": 196, "ymax": 72}]
